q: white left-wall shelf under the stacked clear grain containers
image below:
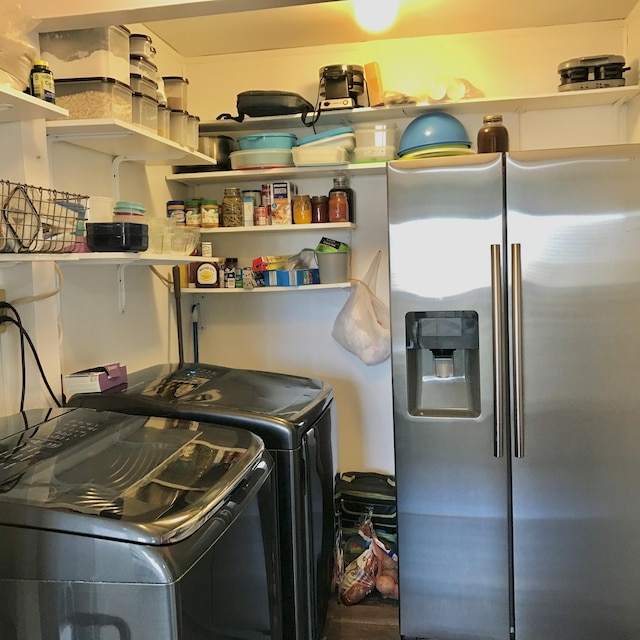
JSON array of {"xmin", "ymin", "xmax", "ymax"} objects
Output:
[{"xmin": 47, "ymin": 118, "xmax": 218, "ymax": 165}]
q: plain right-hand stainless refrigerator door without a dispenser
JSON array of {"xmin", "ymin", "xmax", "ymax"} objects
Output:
[{"xmin": 510, "ymin": 145, "xmax": 640, "ymax": 640}]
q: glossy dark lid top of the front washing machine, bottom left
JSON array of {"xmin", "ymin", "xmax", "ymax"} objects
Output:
[{"xmin": 0, "ymin": 408, "xmax": 264, "ymax": 544}]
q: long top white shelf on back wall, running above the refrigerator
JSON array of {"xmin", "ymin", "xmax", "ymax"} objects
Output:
[{"xmin": 200, "ymin": 85, "xmax": 640, "ymax": 133}]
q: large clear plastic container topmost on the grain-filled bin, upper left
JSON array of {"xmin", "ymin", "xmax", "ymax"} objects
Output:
[{"xmin": 40, "ymin": 26, "xmax": 130, "ymax": 84}]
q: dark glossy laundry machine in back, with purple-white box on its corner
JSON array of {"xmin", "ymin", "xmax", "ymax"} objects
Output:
[{"xmin": 68, "ymin": 363, "xmax": 337, "ymax": 640}]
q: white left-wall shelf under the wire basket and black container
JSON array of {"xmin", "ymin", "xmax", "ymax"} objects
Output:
[{"xmin": 0, "ymin": 251, "xmax": 203, "ymax": 267}]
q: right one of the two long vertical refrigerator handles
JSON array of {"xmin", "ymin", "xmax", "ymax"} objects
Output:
[{"xmin": 511, "ymin": 244, "xmax": 524, "ymax": 458}]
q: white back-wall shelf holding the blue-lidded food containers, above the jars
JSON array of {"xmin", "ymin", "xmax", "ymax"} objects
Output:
[{"xmin": 166, "ymin": 162, "xmax": 387, "ymax": 184}]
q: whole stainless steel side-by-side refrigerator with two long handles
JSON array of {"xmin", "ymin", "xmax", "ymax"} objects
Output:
[{"xmin": 387, "ymin": 145, "xmax": 640, "ymax": 640}]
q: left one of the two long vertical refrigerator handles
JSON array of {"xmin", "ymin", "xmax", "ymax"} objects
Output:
[{"xmin": 491, "ymin": 244, "xmax": 505, "ymax": 458}]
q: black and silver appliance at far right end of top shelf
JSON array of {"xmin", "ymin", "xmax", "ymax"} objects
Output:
[{"xmin": 558, "ymin": 56, "xmax": 630, "ymax": 91}]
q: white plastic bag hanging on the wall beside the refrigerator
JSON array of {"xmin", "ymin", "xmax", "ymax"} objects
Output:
[{"xmin": 331, "ymin": 251, "xmax": 391, "ymax": 365}]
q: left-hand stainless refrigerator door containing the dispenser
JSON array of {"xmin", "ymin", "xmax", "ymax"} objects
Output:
[{"xmin": 387, "ymin": 154, "xmax": 510, "ymax": 640}]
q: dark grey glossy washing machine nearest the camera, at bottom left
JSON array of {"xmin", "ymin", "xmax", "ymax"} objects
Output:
[{"xmin": 0, "ymin": 408, "xmax": 282, "ymax": 640}]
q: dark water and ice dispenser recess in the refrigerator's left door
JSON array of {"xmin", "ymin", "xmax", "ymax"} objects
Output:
[{"xmin": 406, "ymin": 311, "xmax": 480, "ymax": 418}]
